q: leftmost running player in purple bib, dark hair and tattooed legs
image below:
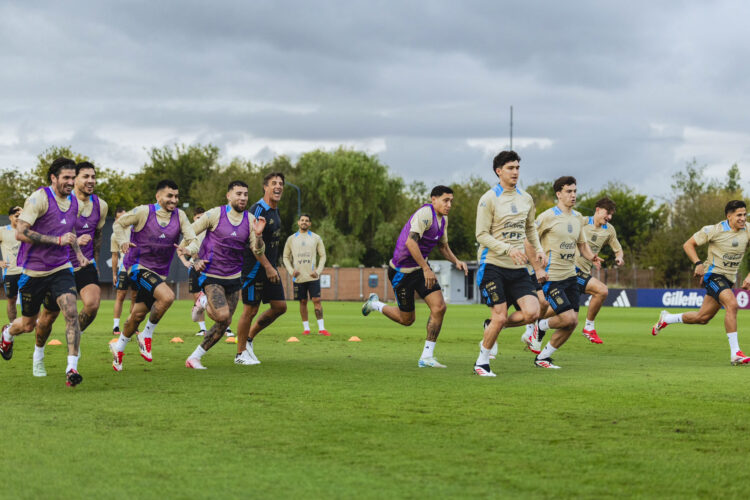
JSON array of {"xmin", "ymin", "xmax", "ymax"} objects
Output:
[{"xmin": 0, "ymin": 157, "xmax": 89, "ymax": 387}]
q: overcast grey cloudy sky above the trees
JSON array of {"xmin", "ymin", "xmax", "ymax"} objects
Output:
[{"xmin": 0, "ymin": 0, "xmax": 750, "ymax": 196}]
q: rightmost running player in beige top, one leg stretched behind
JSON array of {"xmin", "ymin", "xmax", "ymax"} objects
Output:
[{"xmin": 651, "ymin": 200, "xmax": 750, "ymax": 365}]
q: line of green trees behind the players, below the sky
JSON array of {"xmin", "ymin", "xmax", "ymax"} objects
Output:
[{"xmin": 0, "ymin": 144, "xmax": 748, "ymax": 286}]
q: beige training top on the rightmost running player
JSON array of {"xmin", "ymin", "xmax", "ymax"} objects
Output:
[{"xmin": 693, "ymin": 221, "xmax": 748, "ymax": 283}]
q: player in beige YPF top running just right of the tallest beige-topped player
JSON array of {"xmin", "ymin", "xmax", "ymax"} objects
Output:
[{"xmin": 534, "ymin": 176, "xmax": 599, "ymax": 369}]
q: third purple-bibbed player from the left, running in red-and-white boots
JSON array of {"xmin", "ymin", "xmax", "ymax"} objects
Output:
[{"xmin": 109, "ymin": 179, "xmax": 198, "ymax": 372}]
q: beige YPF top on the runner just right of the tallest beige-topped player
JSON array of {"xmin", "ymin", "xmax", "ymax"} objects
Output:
[{"xmin": 536, "ymin": 207, "xmax": 586, "ymax": 281}]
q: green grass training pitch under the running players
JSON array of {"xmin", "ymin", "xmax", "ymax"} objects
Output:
[{"xmin": 0, "ymin": 302, "xmax": 750, "ymax": 499}]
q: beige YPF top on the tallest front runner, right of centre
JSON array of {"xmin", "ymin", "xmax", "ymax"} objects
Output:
[{"xmin": 476, "ymin": 184, "xmax": 542, "ymax": 269}]
